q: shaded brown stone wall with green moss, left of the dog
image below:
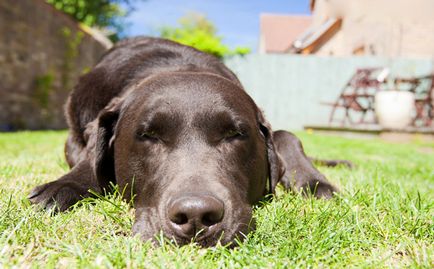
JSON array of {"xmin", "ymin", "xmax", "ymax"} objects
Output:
[{"xmin": 0, "ymin": 0, "xmax": 108, "ymax": 131}]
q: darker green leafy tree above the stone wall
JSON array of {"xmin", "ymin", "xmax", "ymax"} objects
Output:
[{"xmin": 46, "ymin": 0, "xmax": 136, "ymax": 40}]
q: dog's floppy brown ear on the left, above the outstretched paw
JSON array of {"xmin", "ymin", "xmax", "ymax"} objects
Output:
[{"xmin": 93, "ymin": 98, "xmax": 121, "ymax": 189}]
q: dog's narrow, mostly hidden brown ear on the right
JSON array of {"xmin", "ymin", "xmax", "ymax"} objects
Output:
[{"xmin": 258, "ymin": 111, "xmax": 285, "ymax": 194}]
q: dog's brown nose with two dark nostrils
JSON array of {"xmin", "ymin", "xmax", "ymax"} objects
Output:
[{"xmin": 168, "ymin": 195, "xmax": 224, "ymax": 238}]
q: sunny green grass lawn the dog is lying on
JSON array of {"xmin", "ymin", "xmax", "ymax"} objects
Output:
[{"xmin": 0, "ymin": 132, "xmax": 434, "ymax": 268}]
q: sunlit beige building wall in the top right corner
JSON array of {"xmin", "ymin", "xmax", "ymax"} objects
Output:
[{"xmin": 313, "ymin": 0, "xmax": 434, "ymax": 58}]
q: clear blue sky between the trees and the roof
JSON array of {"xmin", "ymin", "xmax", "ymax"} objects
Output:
[{"xmin": 126, "ymin": 0, "xmax": 309, "ymax": 50}]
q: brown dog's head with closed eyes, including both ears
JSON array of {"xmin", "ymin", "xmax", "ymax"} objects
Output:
[{"xmin": 94, "ymin": 72, "xmax": 281, "ymax": 246}]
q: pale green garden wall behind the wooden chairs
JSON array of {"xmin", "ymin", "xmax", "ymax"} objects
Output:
[{"xmin": 225, "ymin": 54, "xmax": 434, "ymax": 130}]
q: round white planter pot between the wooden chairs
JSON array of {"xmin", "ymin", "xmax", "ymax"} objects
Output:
[{"xmin": 375, "ymin": 91, "xmax": 415, "ymax": 129}]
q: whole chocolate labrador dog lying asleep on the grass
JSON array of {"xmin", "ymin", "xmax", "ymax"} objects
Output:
[{"xmin": 29, "ymin": 38, "xmax": 344, "ymax": 246}]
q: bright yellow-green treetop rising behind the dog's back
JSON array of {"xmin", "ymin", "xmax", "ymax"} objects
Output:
[{"xmin": 160, "ymin": 13, "xmax": 250, "ymax": 58}]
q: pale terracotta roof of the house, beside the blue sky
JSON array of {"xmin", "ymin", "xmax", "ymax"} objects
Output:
[{"xmin": 260, "ymin": 14, "xmax": 312, "ymax": 53}]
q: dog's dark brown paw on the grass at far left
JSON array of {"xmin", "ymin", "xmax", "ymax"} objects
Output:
[{"xmin": 27, "ymin": 181, "xmax": 83, "ymax": 212}]
